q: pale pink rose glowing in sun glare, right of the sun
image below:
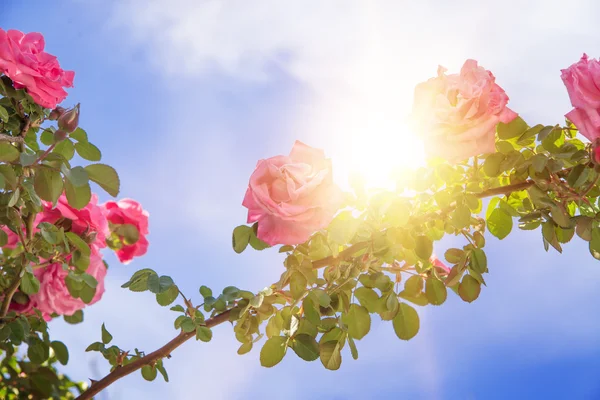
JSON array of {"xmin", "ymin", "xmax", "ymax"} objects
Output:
[{"xmin": 412, "ymin": 60, "xmax": 517, "ymax": 162}]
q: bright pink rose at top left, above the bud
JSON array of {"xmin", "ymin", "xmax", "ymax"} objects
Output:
[{"xmin": 0, "ymin": 28, "xmax": 75, "ymax": 108}]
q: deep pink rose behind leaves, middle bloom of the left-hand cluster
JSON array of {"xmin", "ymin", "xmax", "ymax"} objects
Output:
[{"xmin": 35, "ymin": 194, "xmax": 110, "ymax": 248}]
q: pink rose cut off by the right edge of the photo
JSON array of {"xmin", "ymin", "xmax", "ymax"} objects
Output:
[{"xmin": 561, "ymin": 54, "xmax": 600, "ymax": 141}]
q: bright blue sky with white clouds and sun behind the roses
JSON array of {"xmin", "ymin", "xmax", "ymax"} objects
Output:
[{"xmin": 0, "ymin": 0, "xmax": 600, "ymax": 400}]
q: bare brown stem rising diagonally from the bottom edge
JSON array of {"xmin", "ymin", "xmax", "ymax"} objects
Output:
[{"xmin": 76, "ymin": 310, "xmax": 231, "ymax": 400}]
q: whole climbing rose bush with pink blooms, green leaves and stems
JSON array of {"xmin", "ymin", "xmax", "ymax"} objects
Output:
[{"xmin": 0, "ymin": 29, "xmax": 600, "ymax": 399}]
